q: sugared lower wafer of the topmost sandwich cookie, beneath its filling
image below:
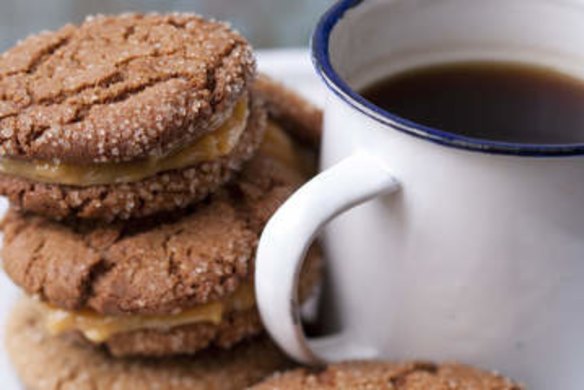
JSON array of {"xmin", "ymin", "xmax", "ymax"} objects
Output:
[{"xmin": 0, "ymin": 99, "xmax": 266, "ymax": 221}]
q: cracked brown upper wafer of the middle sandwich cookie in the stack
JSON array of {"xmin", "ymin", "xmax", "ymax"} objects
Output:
[{"xmin": 2, "ymin": 142, "xmax": 305, "ymax": 315}]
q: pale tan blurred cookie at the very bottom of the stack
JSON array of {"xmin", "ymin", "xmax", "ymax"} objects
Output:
[{"xmin": 6, "ymin": 300, "xmax": 291, "ymax": 390}]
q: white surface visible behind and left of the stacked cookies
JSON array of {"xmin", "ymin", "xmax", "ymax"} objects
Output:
[{"xmin": 0, "ymin": 49, "xmax": 323, "ymax": 390}]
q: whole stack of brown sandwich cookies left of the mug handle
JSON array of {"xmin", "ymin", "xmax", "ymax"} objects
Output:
[{"xmin": 0, "ymin": 14, "xmax": 320, "ymax": 389}]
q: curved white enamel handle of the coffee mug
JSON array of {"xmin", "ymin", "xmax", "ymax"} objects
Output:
[{"xmin": 255, "ymin": 152, "xmax": 399, "ymax": 364}]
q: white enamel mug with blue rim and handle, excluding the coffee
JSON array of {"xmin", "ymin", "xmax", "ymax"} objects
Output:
[{"xmin": 255, "ymin": 0, "xmax": 584, "ymax": 390}]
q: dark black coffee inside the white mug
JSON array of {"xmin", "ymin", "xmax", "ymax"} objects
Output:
[{"xmin": 361, "ymin": 62, "xmax": 584, "ymax": 144}]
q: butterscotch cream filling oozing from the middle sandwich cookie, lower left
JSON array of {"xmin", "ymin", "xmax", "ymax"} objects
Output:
[{"xmin": 44, "ymin": 283, "xmax": 255, "ymax": 343}]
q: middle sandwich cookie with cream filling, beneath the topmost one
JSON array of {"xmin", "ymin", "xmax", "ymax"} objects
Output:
[{"xmin": 2, "ymin": 119, "xmax": 319, "ymax": 356}]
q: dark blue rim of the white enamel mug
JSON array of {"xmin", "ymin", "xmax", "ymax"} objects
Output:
[{"xmin": 311, "ymin": 0, "xmax": 584, "ymax": 157}]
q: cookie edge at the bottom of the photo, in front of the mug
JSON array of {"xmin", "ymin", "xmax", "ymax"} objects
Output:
[{"xmin": 251, "ymin": 361, "xmax": 522, "ymax": 390}]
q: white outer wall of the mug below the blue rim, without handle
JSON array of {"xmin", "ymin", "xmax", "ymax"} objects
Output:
[{"xmin": 322, "ymin": 90, "xmax": 584, "ymax": 390}]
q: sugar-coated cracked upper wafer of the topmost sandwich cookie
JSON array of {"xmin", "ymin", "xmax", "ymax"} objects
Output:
[{"xmin": 0, "ymin": 14, "xmax": 255, "ymax": 164}]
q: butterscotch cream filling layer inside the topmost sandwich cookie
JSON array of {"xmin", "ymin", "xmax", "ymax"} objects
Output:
[{"xmin": 0, "ymin": 97, "xmax": 249, "ymax": 186}]
